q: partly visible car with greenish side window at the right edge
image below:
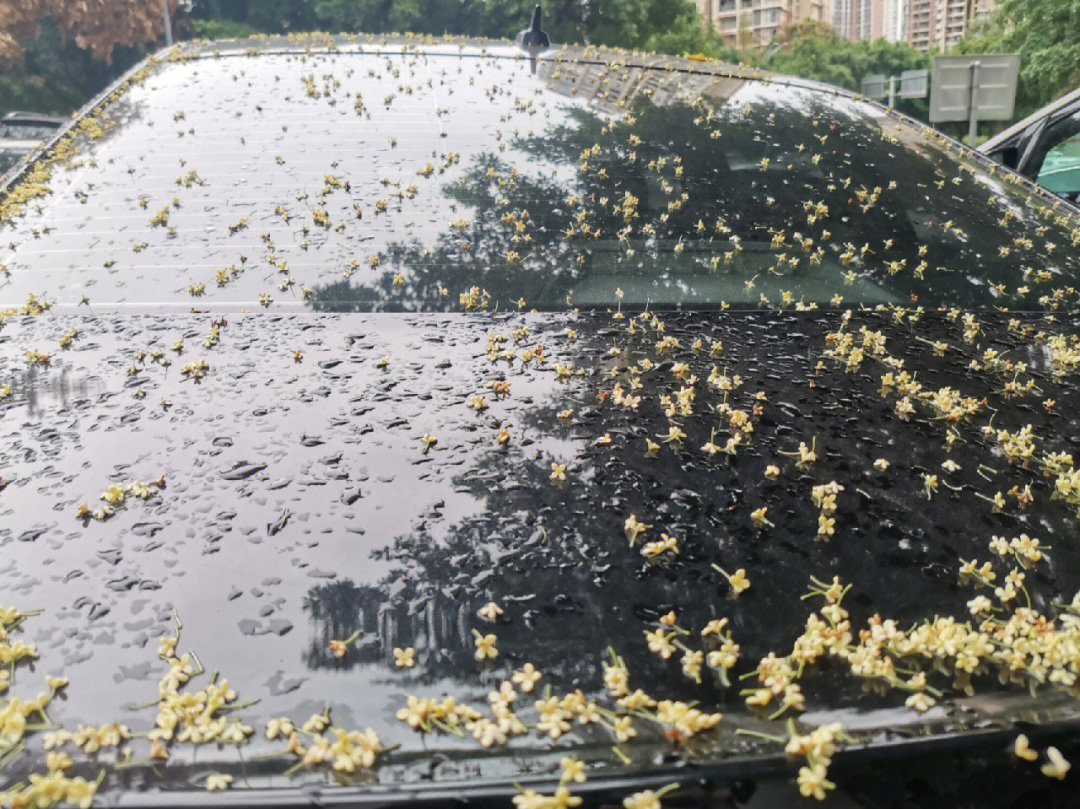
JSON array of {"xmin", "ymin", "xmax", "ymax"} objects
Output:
[{"xmin": 978, "ymin": 87, "xmax": 1080, "ymax": 202}]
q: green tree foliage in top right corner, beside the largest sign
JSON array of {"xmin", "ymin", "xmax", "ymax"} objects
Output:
[{"xmin": 956, "ymin": 0, "xmax": 1080, "ymax": 117}]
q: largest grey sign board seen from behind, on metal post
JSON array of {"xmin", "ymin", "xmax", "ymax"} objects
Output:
[{"xmin": 930, "ymin": 53, "xmax": 1020, "ymax": 146}]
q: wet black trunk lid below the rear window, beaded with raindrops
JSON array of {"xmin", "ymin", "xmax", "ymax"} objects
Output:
[{"xmin": 6, "ymin": 310, "xmax": 1080, "ymax": 788}]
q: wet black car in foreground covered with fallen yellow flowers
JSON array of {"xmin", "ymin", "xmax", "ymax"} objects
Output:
[{"xmin": 0, "ymin": 29, "xmax": 1080, "ymax": 809}]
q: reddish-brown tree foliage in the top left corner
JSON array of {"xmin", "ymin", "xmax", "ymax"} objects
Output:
[{"xmin": 0, "ymin": 0, "xmax": 179, "ymax": 65}]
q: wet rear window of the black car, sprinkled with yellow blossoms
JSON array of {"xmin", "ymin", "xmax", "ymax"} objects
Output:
[{"xmin": 0, "ymin": 44, "xmax": 1080, "ymax": 311}]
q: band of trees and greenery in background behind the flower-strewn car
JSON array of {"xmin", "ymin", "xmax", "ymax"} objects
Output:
[{"xmin": 0, "ymin": 0, "xmax": 1080, "ymax": 125}]
